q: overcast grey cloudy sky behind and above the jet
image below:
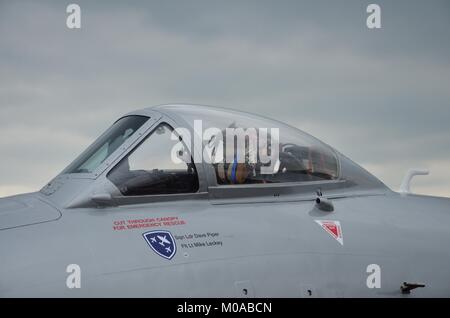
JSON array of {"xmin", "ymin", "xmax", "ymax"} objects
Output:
[{"xmin": 0, "ymin": 0, "xmax": 450, "ymax": 197}]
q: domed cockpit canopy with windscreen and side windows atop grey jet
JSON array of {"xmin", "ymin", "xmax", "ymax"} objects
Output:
[{"xmin": 43, "ymin": 105, "xmax": 384, "ymax": 206}]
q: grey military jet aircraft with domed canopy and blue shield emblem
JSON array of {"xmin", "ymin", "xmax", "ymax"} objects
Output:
[{"xmin": 0, "ymin": 104, "xmax": 450, "ymax": 297}]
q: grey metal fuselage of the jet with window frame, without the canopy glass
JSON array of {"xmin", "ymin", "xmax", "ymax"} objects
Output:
[{"xmin": 0, "ymin": 105, "xmax": 450, "ymax": 297}]
